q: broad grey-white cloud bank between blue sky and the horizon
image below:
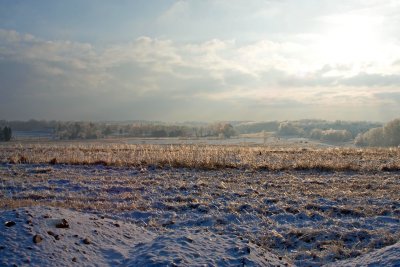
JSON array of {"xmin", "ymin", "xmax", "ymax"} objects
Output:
[{"xmin": 0, "ymin": 30, "xmax": 400, "ymax": 120}]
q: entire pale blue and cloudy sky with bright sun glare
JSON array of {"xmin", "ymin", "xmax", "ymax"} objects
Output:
[{"xmin": 0, "ymin": 0, "xmax": 400, "ymax": 122}]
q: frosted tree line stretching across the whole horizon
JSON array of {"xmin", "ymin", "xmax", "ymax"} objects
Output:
[{"xmin": 4, "ymin": 119, "xmax": 400, "ymax": 146}]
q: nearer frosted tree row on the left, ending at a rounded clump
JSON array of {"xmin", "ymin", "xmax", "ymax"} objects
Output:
[{"xmin": 0, "ymin": 120, "xmax": 235, "ymax": 140}]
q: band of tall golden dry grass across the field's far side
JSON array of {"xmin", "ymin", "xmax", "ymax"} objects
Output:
[{"xmin": 0, "ymin": 144, "xmax": 400, "ymax": 171}]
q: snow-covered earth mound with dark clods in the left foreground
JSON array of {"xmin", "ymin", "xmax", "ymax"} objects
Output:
[{"xmin": 0, "ymin": 206, "xmax": 291, "ymax": 266}]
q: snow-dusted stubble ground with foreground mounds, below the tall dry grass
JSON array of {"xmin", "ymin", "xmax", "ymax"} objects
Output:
[{"xmin": 0, "ymin": 164, "xmax": 400, "ymax": 266}]
